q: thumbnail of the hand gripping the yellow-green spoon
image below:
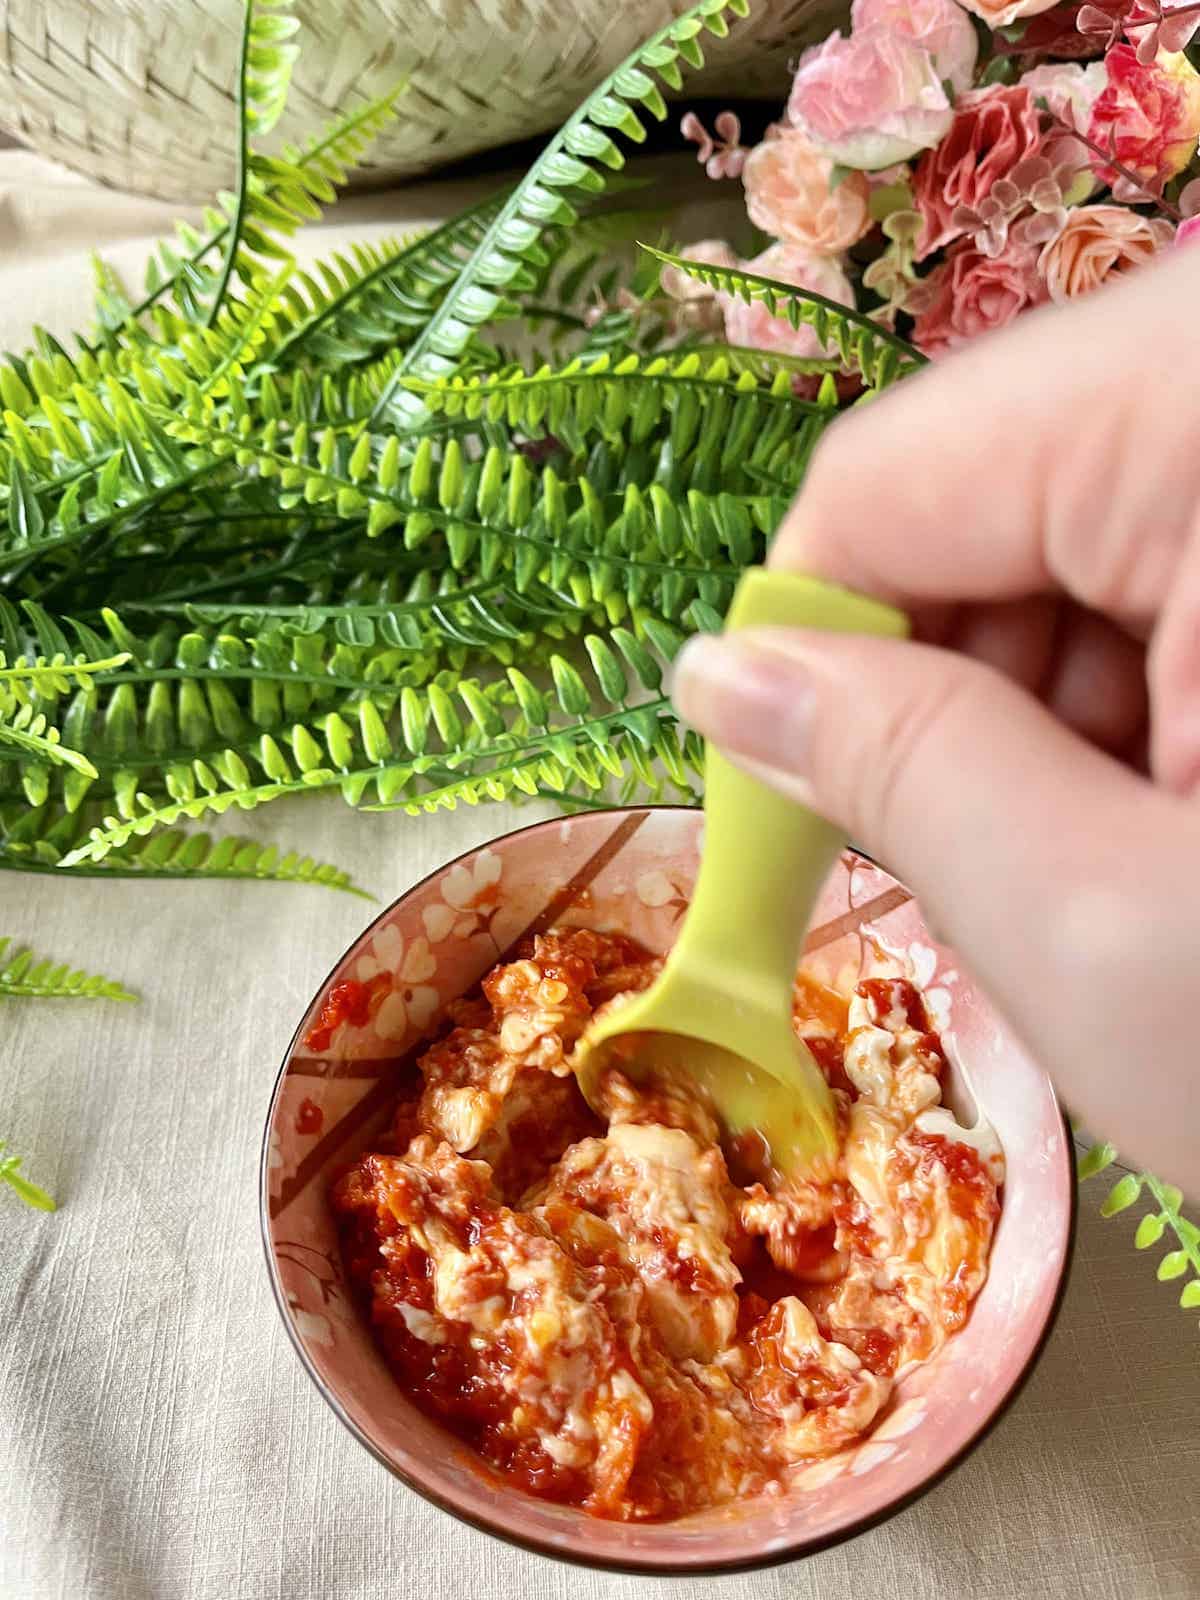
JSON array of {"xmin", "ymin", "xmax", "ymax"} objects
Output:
[{"xmin": 670, "ymin": 634, "xmax": 813, "ymax": 792}]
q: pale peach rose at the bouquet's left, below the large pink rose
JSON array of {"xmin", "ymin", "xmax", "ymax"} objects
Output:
[{"xmin": 742, "ymin": 130, "xmax": 870, "ymax": 256}]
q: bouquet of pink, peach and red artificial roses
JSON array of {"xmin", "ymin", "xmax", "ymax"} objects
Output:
[{"xmin": 662, "ymin": 0, "xmax": 1200, "ymax": 360}]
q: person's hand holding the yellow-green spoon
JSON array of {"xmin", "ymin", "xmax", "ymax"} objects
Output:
[{"xmin": 675, "ymin": 248, "xmax": 1200, "ymax": 1194}]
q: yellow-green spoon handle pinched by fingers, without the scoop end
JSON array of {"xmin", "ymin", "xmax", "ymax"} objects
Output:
[{"xmin": 670, "ymin": 566, "xmax": 909, "ymax": 1013}]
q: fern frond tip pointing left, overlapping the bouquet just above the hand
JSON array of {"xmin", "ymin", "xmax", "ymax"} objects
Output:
[{"xmin": 642, "ymin": 245, "xmax": 926, "ymax": 389}]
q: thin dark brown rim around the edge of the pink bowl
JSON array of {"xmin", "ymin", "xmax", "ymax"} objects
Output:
[{"xmin": 259, "ymin": 805, "xmax": 1078, "ymax": 1578}]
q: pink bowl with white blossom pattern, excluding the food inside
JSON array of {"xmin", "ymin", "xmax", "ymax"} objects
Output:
[{"xmin": 262, "ymin": 808, "xmax": 1075, "ymax": 1573}]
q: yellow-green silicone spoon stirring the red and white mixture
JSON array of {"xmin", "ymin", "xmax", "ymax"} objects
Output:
[{"xmin": 574, "ymin": 566, "xmax": 907, "ymax": 1176}]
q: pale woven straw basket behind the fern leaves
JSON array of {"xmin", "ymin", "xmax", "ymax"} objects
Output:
[{"xmin": 0, "ymin": 0, "xmax": 846, "ymax": 202}]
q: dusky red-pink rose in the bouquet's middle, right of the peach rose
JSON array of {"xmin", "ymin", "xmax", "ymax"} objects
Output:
[{"xmin": 912, "ymin": 85, "xmax": 1042, "ymax": 259}]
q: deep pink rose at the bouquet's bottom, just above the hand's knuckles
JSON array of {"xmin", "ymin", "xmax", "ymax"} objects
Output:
[{"xmin": 912, "ymin": 226, "xmax": 1046, "ymax": 357}]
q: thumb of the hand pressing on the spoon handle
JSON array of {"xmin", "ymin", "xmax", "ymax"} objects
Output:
[{"xmin": 674, "ymin": 629, "xmax": 1200, "ymax": 1190}]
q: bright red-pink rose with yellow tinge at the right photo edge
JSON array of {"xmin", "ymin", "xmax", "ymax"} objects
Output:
[{"xmin": 1088, "ymin": 45, "xmax": 1200, "ymax": 202}]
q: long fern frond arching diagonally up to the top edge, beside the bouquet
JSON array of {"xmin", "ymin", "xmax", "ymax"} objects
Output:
[{"xmin": 371, "ymin": 0, "xmax": 749, "ymax": 426}]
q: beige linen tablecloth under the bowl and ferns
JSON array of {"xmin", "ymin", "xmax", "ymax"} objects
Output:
[{"xmin": 0, "ymin": 154, "xmax": 1200, "ymax": 1600}]
